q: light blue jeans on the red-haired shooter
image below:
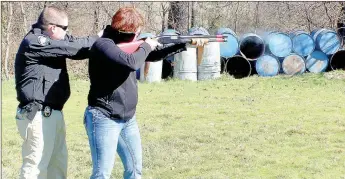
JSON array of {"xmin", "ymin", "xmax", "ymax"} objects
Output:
[{"xmin": 84, "ymin": 106, "xmax": 142, "ymax": 179}]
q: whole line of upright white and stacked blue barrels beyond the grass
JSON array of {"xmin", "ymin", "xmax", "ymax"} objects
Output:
[{"xmin": 137, "ymin": 27, "xmax": 345, "ymax": 82}]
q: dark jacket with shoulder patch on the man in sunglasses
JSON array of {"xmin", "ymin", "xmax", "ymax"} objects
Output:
[{"xmin": 15, "ymin": 24, "xmax": 98, "ymax": 110}]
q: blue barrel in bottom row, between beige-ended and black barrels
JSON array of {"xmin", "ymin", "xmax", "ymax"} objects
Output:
[{"xmin": 306, "ymin": 50, "xmax": 329, "ymax": 73}]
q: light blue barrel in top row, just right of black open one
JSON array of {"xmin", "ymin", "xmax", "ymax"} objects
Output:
[{"xmin": 266, "ymin": 32, "xmax": 292, "ymax": 57}]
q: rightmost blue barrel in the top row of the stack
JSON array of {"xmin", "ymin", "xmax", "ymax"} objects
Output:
[{"xmin": 311, "ymin": 29, "xmax": 341, "ymax": 55}]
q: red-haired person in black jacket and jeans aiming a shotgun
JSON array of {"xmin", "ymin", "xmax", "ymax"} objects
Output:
[{"xmin": 84, "ymin": 7, "xmax": 186, "ymax": 179}]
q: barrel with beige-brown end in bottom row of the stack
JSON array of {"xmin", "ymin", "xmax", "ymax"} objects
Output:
[{"xmin": 282, "ymin": 54, "xmax": 306, "ymax": 75}]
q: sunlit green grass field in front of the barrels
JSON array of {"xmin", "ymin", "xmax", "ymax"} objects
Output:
[{"xmin": 2, "ymin": 71, "xmax": 345, "ymax": 179}]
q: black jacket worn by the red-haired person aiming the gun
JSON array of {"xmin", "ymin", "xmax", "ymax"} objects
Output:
[{"xmin": 88, "ymin": 26, "xmax": 186, "ymax": 120}]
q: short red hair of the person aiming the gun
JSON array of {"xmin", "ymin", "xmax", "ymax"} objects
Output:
[{"xmin": 111, "ymin": 7, "xmax": 144, "ymax": 33}]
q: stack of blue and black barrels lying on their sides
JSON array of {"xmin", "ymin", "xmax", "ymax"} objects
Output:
[{"xmin": 217, "ymin": 28, "xmax": 345, "ymax": 78}]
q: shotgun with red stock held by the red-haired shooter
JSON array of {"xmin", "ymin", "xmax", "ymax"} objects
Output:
[{"xmin": 117, "ymin": 35, "xmax": 227, "ymax": 53}]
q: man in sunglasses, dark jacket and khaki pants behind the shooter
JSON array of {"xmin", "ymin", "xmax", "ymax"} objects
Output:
[{"xmin": 15, "ymin": 6, "xmax": 98, "ymax": 179}]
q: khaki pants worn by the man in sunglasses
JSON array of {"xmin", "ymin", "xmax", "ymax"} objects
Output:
[{"xmin": 16, "ymin": 108, "xmax": 67, "ymax": 179}]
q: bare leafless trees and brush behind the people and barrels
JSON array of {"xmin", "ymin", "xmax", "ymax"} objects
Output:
[{"xmin": 1, "ymin": 1, "xmax": 345, "ymax": 79}]
